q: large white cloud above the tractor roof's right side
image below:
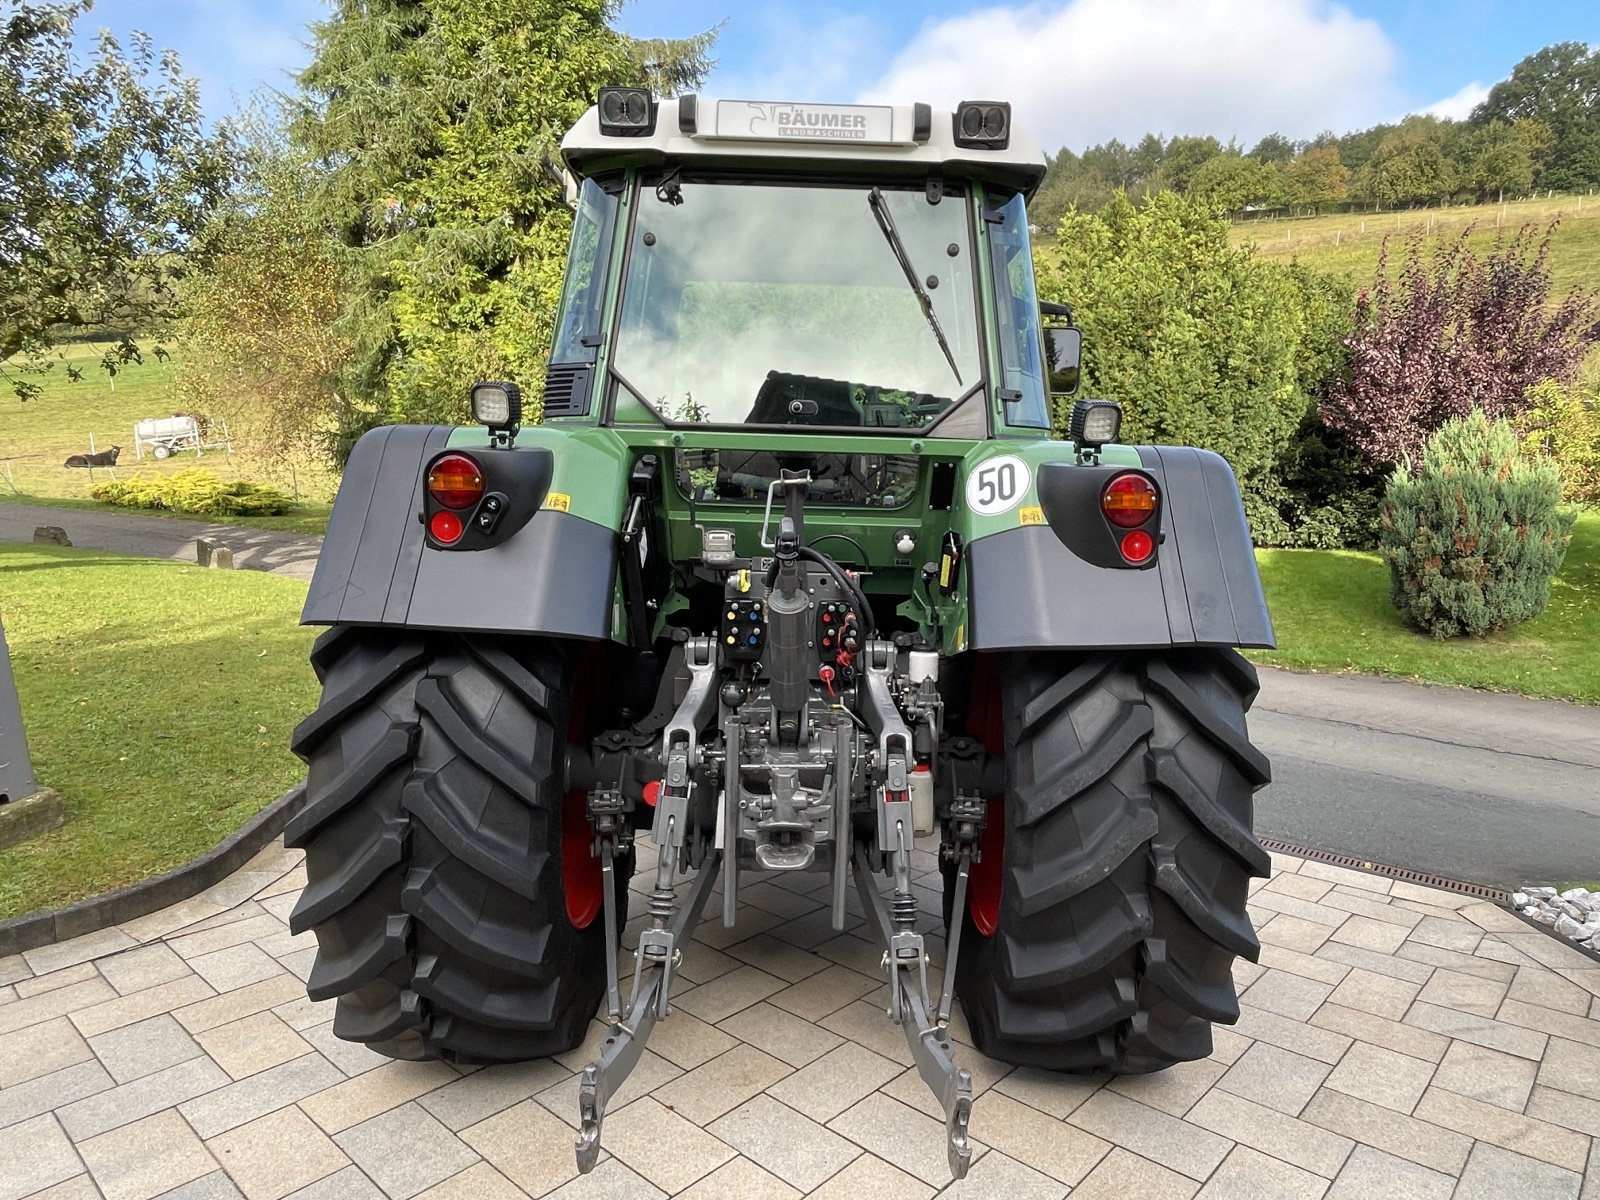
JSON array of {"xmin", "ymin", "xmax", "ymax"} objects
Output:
[{"xmin": 861, "ymin": 0, "xmax": 1405, "ymax": 150}]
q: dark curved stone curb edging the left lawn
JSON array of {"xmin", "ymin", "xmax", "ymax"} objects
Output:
[{"xmin": 0, "ymin": 784, "xmax": 306, "ymax": 958}]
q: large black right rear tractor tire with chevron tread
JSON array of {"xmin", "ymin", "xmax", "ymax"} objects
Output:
[{"xmin": 946, "ymin": 650, "xmax": 1270, "ymax": 1074}]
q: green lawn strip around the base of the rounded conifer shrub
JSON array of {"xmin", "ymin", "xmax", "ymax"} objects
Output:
[{"xmin": 1251, "ymin": 512, "xmax": 1600, "ymax": 704}]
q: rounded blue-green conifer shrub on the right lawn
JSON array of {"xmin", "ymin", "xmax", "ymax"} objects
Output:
[{"xmin": 1379, "ymin": 413, "xmax": 1576, "ymax": 638}]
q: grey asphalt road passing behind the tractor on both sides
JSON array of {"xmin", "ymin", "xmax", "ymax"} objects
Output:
[{"xmin": 0, "ymin": 504, "xmax": 1600, "ymax": 888}]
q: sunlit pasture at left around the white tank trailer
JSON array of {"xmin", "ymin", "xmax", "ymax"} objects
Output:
[{"xmin": 0, "ymin": 344, "xmax": 338, "ymax": 530}]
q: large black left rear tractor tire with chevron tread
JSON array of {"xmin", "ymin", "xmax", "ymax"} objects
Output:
[{"xmin": 285, "ymin": 626, "xmax": 632, "ymax": 1062}]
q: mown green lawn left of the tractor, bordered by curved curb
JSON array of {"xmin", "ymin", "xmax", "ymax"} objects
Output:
[{"xmin": 0, "ymin": 542, "xmax": 317, "ymax": 917}]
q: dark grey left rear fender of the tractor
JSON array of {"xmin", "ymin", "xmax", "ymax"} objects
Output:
[{"xmin": 301, "ymin": 426, "xmax": 618, "ymax": 640}]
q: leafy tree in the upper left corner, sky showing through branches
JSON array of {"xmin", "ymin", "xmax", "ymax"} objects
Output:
[{"xmin": 0, "ymin": 0, "xmax": 230, "ymax": 400}]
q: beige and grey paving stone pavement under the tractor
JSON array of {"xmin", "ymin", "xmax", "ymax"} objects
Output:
[{"xmin": 0, "ymin": 842, "xmax": 1600, "ymax": 1200}]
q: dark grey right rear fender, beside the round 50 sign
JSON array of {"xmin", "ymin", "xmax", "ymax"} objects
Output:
[{"xmin": 968, "ymin": 446, "xmax": 1277, "ymax": 650}]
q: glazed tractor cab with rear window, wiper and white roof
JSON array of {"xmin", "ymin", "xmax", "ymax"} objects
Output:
[{"xmin": 544, "ymin": 88, "xmax": 1068, "ymax": 440}]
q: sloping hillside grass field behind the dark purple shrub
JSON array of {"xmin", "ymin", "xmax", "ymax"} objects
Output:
[{"xmin": 1234, "ymin": 195, "xmax": 1600, "ymax": 296}]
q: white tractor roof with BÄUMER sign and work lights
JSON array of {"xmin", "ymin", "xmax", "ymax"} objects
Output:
[{"xmin": 562, "ymin": 96, "xmax": 1045, "ymax": 192}]
